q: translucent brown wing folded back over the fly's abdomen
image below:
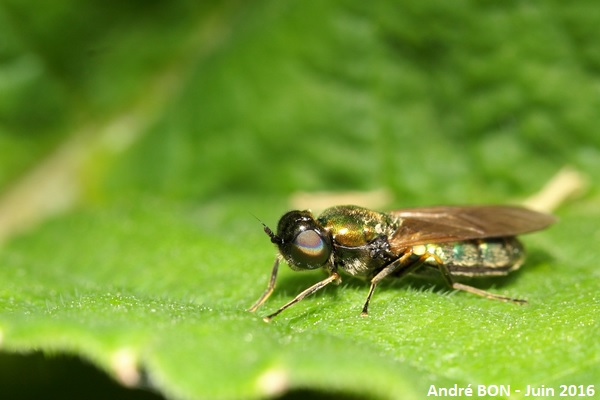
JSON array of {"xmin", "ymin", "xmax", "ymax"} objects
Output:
[{"xmin": 389, "ymin": 206, "xmax": 556, "ymax": 248}]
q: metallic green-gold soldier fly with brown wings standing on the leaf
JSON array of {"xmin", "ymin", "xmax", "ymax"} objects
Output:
[{"xmin": 248, "ymin": 206, "xmax": 555, "ymax": 322}]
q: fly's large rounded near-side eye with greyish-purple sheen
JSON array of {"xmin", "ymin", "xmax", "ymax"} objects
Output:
[{"xmin": 289, "ymin": 229, "xmax": 331, "ymax": 269}]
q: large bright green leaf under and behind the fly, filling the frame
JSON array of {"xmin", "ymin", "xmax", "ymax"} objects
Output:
[{"xmin": 0, "ymin": 0, "xmax": 600, "ymax": 398}]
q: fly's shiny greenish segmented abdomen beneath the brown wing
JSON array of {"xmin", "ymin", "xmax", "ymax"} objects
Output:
[{"xmin": 413, "ymin": 237, "xmax": 525, "ymax": 276}]
